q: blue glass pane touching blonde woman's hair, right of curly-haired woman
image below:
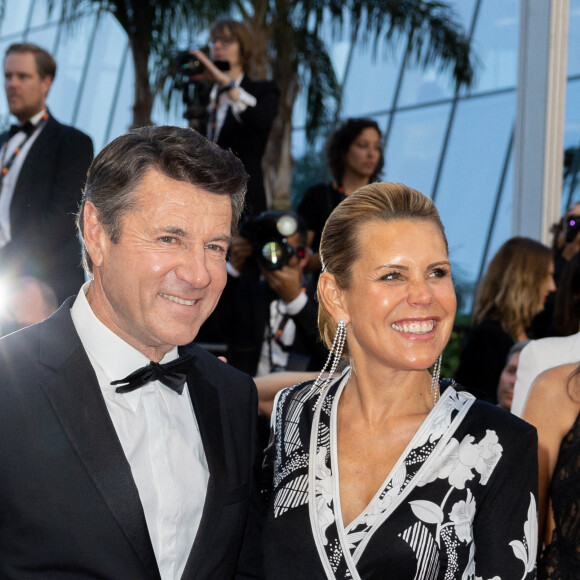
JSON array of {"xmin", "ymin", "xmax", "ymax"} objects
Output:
[{"xmin": 383, "ymin": 104, "xmax": 451, "ymax": 196}]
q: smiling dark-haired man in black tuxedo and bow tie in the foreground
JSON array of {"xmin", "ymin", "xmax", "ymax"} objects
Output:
[{"xmin": 0, "ymin": 127, "xmax": 262, "ymax": 580}]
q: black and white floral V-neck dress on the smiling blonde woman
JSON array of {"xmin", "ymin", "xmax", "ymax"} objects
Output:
[{"xmin": 264, "ymin": 369, "xmax": 538, "ymax": 580}]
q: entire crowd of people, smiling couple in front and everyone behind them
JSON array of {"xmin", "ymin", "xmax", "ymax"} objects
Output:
[{"xmin": 0, "ymin": 19, "xmax": 580, "ymax": 580}]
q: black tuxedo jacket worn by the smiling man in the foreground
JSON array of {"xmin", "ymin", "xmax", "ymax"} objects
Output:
[{"xmin": 0, "ymin": 299, "xmax": 262, "ymax": 580}]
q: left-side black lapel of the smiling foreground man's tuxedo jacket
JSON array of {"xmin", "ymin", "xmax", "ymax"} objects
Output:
[{"xmin": 39, "ymin": 299, "xmax": 160, "ymax": 578}]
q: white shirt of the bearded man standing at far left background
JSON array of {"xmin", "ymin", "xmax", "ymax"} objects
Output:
[{"xmin": 0, "ymin": 109, "xmax": 46, "ymax": 248}]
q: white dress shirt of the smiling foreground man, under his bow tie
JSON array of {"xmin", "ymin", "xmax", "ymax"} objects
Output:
[{"xmin": 71, "ymin": 282, "xmax": 209, "ymax": 580}]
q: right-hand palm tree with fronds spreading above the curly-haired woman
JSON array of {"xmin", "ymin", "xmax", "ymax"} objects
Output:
[{"xmin": 235, "ymin": 0, "xmax": 474, "ymax": 205}]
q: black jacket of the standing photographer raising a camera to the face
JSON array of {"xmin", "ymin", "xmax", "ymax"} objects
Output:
[{"xmin": 202, "ymin": 75, "xmax": 280, "ymax": 215}]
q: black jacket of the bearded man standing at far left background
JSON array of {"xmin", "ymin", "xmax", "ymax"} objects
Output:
[{"xmin": 0, "ymin": 117, "xmax": 93, "ymax": 303}]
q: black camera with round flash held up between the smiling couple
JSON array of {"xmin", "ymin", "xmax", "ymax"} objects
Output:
[{"xmin": 240, "ymin": 210, "xmax": 306, "ymax": 271}]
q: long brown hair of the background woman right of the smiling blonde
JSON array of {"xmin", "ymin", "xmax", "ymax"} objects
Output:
[{"xmin": 473, "ymin": 237, "xmax": 553, "ymax": 340}]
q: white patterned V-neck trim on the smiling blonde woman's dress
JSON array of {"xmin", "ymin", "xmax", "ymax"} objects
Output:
[{"xmin": 308, "ymin": 370, "xmax": 474, "ymax": 580}]
